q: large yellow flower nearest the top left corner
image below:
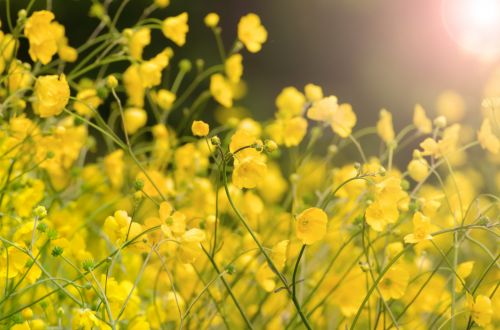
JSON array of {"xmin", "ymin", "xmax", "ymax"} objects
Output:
[{"xmin": 24, "ymin": 10, "xmax": 57, "ymax": 64}]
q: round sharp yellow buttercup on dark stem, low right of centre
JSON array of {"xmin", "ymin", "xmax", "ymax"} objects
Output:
[{"xmin": 295, "ymin": 207, "xmax": 328, "ymax": 245}]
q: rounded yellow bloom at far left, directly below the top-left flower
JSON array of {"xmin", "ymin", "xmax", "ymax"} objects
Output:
[{"xmin": 33, "ymin": 75, "xmax": 70, "ymax": 118}]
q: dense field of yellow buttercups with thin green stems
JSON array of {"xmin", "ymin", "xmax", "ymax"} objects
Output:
[{"xmin": 0, "ymin": 0, "xmax": 500, "ymax": 330}]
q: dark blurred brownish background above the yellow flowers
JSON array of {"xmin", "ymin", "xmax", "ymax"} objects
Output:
[{"xmin": 0, "ymin": 0, "xmax": 500, "ymax": 128}]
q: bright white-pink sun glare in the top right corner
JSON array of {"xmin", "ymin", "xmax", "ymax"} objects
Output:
[{"xmin": 442, "ymin": 0, "xmax": 500, "ymax": 60}]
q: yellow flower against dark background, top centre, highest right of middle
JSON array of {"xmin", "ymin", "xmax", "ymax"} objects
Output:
[{"xmin": 238, "ymin": 13, "xmax": 267, "ymax": 53}]
